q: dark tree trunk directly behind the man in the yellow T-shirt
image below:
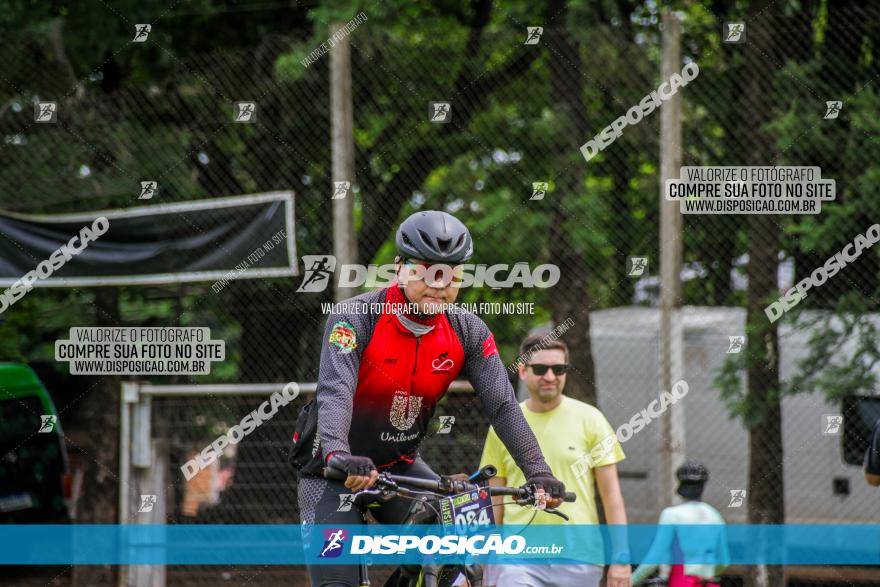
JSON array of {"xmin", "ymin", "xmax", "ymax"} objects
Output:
[{"xmin": 544, "ymin": 0, "xmax": 596, "ymax": 405}]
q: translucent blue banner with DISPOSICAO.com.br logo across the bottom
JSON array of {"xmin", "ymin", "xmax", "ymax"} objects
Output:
[{"xmin": 0, "ymin": 524, "xmax": 880, "ymax": 565}]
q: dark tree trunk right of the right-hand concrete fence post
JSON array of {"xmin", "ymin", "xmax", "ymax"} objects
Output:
[{"xmin": 743, "ymin": 0, "xmax": 785, "ymax": 587}]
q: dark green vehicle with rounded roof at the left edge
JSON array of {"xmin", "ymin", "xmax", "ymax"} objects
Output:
[{"xmin": 0, "ymin": 363, "xmax": 71, "ymax": 524}]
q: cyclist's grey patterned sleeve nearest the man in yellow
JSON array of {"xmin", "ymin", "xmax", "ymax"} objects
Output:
[{"xmin": 457, "ymin": 312, "xmax": 552, "ymax": 479}]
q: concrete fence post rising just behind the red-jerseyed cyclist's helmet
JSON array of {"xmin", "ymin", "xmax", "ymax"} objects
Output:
[{"xmin": 330, "ymin": 22, "xmax": 357, "ymax": 301}]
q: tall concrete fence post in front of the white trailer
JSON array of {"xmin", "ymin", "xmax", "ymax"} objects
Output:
[{"xmin": 658, "ymin": 12, "xmax": 685, "ymax": 508}]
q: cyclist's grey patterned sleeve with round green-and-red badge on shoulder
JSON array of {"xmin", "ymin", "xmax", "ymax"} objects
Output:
[{"xmin": 315, "ymin": 306, "xmax": 371, "ymax": 461}]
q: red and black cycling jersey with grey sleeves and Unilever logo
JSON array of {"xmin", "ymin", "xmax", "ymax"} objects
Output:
[{"xmin": 303, "ymin": 285, "xmax": 552, "ymax": 478}]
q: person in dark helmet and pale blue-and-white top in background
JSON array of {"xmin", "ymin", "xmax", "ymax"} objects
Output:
[{"xmin": 632, "ymin": 460, "xmax": 730, "ymax": 587}]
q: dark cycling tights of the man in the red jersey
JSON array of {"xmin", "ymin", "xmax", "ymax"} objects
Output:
[{"xmin": 298, "ymin": 457, "xmax": 440, "ymax": 587}]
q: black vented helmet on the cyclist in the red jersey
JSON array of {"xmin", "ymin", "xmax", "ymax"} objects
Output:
[{"xmin": 396, "ymin": 210, "xmax": 474, "ymax": 265}]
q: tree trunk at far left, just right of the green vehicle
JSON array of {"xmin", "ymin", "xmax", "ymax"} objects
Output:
[{"xmin": 73, "ymin": 287, "xmax": 126, "ymax": 587}]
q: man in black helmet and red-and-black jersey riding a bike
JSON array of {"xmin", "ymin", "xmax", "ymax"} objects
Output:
[{"xmin": 290, "ymin": 211, "xmax": 565, "ymax": 587}]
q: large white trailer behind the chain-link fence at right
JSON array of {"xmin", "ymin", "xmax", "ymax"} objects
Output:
[{"xmin": 590, "ymin": 307, "xmax": 880, "ymax": 524}]
